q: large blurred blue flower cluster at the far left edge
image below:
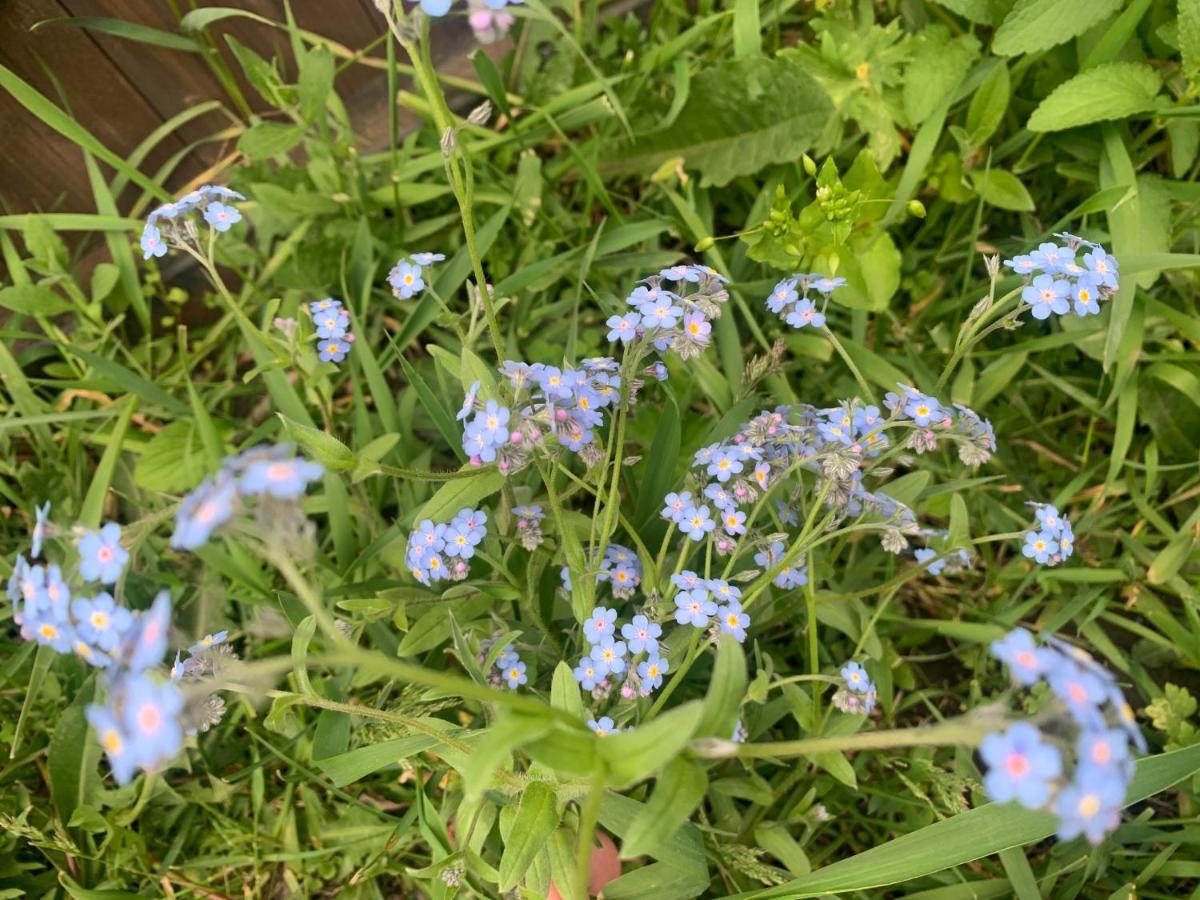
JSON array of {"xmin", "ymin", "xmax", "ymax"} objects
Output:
[{"xmin": 8, "ymin": 505, "xmax": 184, "ymax": 784}]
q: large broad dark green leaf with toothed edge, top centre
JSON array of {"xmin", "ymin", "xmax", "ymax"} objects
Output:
[{"xmin": 604, "ymin": 56, "xmax": 832, "ymax": 185}]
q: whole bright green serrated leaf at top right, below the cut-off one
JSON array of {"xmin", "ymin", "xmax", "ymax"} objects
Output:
[{"xmin": 1027, "ymin": 62, "xmax": 1162, "ymax": 131}]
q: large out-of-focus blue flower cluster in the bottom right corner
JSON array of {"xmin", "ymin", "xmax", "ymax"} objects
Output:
[{"xmin": 979, "ymin": 628, "xmax": 1146, "ymax": 844}]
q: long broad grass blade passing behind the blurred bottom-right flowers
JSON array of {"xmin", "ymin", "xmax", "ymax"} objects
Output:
[{"xmin": 736, "ymin": 744, "xmax": 1200, "ymax": 900}]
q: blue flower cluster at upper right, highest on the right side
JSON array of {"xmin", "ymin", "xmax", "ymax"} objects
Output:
[{"xmin": 1004, "ymin": 232, "xmax": 1120, "ymax": 319}]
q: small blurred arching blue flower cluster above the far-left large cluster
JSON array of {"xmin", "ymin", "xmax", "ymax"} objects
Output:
[{"xmin": 170, "ymin": 444, "xmax": 325, "ymax": 550}]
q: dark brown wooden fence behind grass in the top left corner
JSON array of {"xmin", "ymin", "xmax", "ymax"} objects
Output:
[{"xmin": 0, "ymin": 0, "xmax": 484, "ymax": 212}]
